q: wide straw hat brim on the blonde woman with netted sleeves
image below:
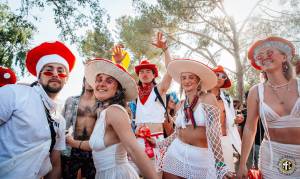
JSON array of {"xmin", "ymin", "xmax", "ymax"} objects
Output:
[{"xmin": 167, "ymin": 59, "xmax": 217, "ymax": 91}]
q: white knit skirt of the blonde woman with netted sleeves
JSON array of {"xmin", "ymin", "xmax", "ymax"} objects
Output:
[{"xmin": 162, "ymin": 138, "xmax": 216, "ymax": 179}]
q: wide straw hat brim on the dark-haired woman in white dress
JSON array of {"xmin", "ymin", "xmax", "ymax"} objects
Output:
[{"xmin": 84, "ymin": 59, "xmax": 138, "ymax": 101}]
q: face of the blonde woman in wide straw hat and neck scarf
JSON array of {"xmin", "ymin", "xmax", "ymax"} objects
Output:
[{"xmin": 180, "ymin": 72, "xmax": 200, "ymax": 93}]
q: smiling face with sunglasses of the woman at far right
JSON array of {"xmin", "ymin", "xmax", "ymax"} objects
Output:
[{"xmin": 255, "ymin": 47, "xmax": 287, "ymax": 72}]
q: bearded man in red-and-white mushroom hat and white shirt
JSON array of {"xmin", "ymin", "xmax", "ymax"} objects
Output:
[{"xmin": 0, "ymin": 41, "xmax": 75, "ymax": 179}]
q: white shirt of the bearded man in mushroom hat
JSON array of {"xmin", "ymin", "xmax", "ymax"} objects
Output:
[{"xmin": 0, "ymin": 85, "xmax": 65, "ymax": 178}]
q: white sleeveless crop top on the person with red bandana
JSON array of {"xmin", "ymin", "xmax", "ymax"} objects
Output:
[{"xmin": 135, "ymin": 88, "xmax": 165, "ymax": 124}]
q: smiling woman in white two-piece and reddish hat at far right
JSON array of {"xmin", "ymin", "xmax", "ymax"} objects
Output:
[{"xmin": 238, "ymin": 37, "xmax": 300, "ymax": 179}]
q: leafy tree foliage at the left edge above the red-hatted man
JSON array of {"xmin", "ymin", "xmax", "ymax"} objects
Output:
[{"xmin": 0, "ymin": 4, "xmax": 35, "ymax": 75}]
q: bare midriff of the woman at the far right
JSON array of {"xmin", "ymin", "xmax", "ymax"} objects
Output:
[{"xmin": 268, "ymin": 127, "xmax": 300, "ymax": 145}]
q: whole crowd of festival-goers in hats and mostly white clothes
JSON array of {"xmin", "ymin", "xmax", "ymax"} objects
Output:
[{"xmin": 0, "ymin": 32, "xmax": 300, "ymax": 179}]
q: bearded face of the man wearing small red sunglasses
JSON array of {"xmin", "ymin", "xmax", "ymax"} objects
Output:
[{"xmin": 39, "ymin": 63, "xmax": 68, "ymax": 93}]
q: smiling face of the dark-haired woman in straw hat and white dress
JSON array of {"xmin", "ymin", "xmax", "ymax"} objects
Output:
[{"xmin": 94, "ymin": 74, "xmax": 119, "ymax": 101}]
